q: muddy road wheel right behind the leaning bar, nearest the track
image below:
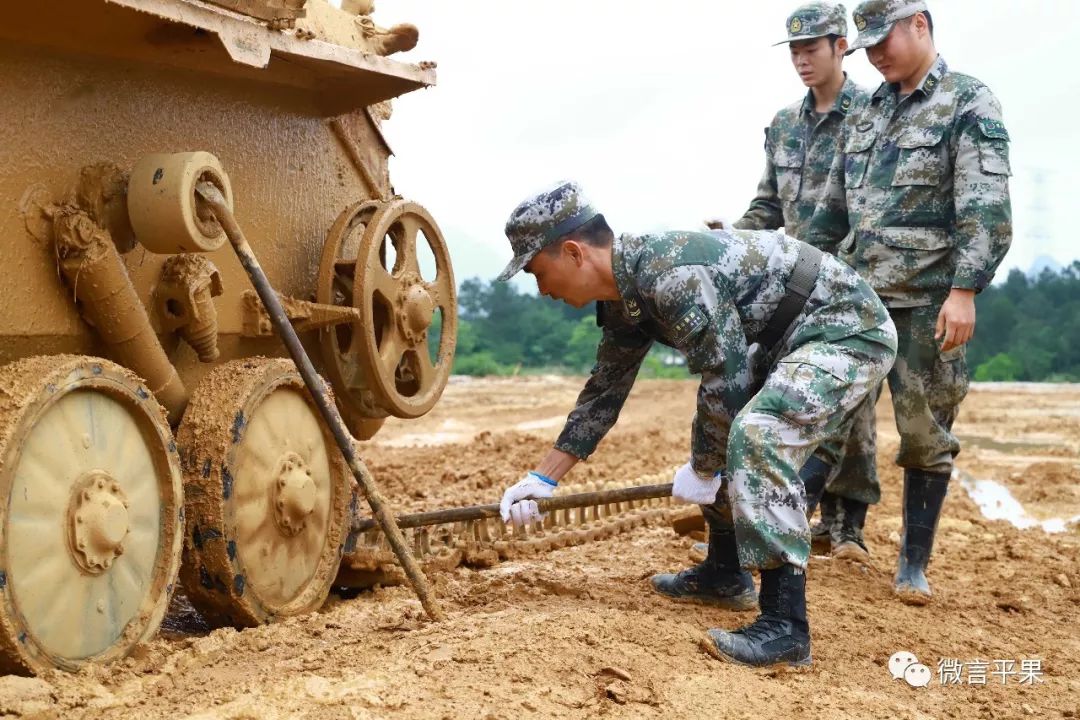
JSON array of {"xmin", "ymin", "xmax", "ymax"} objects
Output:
[{"xmin": 177, "ymin": 357, "xmax": 352, "ymax": 626}]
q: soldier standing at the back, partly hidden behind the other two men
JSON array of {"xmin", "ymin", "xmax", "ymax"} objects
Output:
[{"xmin": 708, "ymin": 2, "xmax": 881, "ymax": 569}]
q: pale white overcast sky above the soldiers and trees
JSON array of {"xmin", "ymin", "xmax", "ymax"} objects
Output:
[{"xmin": 352, "ymin": 0, "xmax": 1080, "ymax": 289}]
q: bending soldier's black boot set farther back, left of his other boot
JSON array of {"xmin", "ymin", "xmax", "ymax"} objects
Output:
[{"xmin": 650, "ymin": 508, "xmax": 757, "ymax": 610}]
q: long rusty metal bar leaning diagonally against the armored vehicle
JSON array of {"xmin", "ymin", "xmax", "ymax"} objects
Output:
[{"xmin": 195, "ymin": 182, "xmax": 444, "ymax": 621}]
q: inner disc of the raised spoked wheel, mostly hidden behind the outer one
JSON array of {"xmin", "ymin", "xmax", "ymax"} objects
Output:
[{"xmin": 315, "ymin": 201, "xmax": 387, "ymax": 440}]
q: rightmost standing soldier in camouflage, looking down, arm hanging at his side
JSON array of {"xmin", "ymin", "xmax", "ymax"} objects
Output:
[{"xmin": 834, "ymin": 0, "xmax": 1012, "ymax": 604}]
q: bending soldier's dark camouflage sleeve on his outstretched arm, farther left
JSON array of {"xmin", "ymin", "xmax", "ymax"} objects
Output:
[{"xmin": 555, "ymin": 306, "xmax": 652, "ymax": 460}]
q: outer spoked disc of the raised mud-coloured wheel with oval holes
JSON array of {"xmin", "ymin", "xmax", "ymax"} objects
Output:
[{"xmin": 353, "ymin": 200, "xmax": 458, "ymax": 418}]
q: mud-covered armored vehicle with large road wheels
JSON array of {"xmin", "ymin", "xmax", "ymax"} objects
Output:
[{"xmin": 0, "ymin": 0, "xmax": 457, "ymax": 673}]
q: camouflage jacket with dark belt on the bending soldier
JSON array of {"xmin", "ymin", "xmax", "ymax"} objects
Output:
[{"xmin": 555, "ymin": 230, "xmax": 889, "ymax": 473}]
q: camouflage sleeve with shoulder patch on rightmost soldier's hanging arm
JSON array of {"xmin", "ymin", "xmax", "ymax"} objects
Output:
[{"xmin": 953, "ymin": 91, "xmax": 1012, "ymax": 290}]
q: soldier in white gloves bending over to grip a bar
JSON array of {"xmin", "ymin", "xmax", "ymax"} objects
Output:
[{"xmin": 499, "ymin": 182, "xmax": 896, "ymax": 666}]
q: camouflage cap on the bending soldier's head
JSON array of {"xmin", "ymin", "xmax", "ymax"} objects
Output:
[{"xmin": 498, "ymin": 180, "xmax": 598, "ymax": 281}]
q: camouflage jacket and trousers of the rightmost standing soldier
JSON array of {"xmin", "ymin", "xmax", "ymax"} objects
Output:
[{"xmin": 835, "ymin": 53, "xmax": 1012, "ymax": 473}]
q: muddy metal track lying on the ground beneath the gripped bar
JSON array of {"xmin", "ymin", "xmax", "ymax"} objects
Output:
[{"xmin": 336, "ymin": 471, "xmax": 692, "ymax": 588}]
